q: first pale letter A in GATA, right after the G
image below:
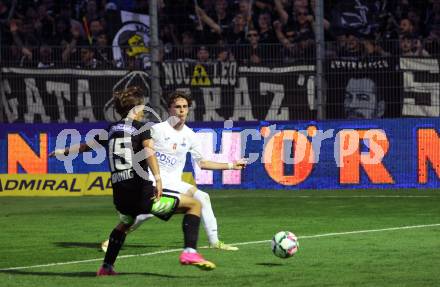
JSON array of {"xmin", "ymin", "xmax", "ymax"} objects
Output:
[{"xmin": 24, "ymin": 78, "xmax": 50, "ymax": 123}]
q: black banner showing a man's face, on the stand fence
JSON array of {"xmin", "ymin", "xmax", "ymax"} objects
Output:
[{"xmin": 326, "ymin": 57, "xmax": 402, "ymax": 119}]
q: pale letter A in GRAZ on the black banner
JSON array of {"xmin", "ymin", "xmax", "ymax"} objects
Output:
[{"xmin": 231, "ymin": 77, "xmax": 256, "ymax": 121}]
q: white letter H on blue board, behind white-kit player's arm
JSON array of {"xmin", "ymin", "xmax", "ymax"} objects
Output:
[{"xmin": 193, "ymin": 131, "xmax": 241, "ymax": 184}]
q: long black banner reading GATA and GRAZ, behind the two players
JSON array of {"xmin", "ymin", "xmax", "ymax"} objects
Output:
[{"xmin": 0, "ymin": 62, "xmax": 316, "ymax": 123}]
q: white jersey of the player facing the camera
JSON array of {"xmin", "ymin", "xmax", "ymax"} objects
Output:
[{"xmin": 149, "ymin": 121, "xmax": 203, "ymax": 188}]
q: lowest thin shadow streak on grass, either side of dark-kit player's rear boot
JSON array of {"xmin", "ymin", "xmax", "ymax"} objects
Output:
[{"xmin": 0, "ymin": 270, "xmax": 189, "ymax": 278}]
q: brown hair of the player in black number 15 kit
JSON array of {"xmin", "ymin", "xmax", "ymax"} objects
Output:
[{"xmin": 113, "ymin": 86, "xmax": 144, "ymax": 118}]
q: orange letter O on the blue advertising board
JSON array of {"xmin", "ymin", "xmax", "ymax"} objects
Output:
[{"xmin": 263, "ymin": 130, "xmax": 313, "ymax": 185}]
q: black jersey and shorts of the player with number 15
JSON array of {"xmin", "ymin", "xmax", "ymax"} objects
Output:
[{"xmin": 107, "ymin": 120, "xmax": 154, "ymax": 216}]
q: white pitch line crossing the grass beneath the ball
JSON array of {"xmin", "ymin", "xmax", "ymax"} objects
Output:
[{"xmin": 0, "ymin": 223, "xmax": 440, "ymax": 272}]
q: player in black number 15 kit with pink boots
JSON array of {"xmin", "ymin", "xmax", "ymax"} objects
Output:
[{"xmin": 50, "ymin": 87, "xmax": 215, "ymax": 276}]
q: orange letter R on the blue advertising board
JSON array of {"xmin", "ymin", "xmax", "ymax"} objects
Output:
[{"xmin": 339, "ymin": 130, "xmax": 394, "ymax": 184}]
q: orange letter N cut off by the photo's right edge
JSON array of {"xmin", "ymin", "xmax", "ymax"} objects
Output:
[{"xmin": 417, "ymin": 129, "xmax": 440, "ymax": 183}]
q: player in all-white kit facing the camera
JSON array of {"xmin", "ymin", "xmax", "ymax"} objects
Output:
[{"xmin": 101, "ymin": 92, "xmax": 246, "ymax": 251}]
